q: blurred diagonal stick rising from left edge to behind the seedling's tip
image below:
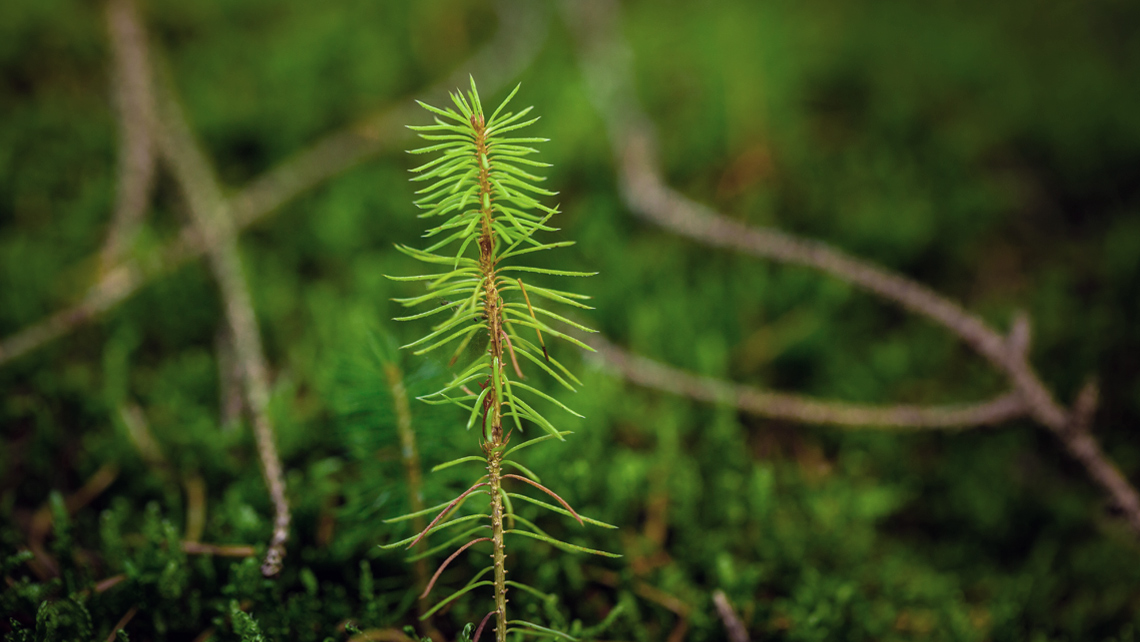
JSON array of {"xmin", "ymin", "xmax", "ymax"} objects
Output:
[{"xmin": 0, "ymin": 1, "xmax": 548, "ymax": 366}]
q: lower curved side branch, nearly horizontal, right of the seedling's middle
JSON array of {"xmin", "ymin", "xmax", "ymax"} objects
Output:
[{"xmin": 584, "ymin": 335, "xmax": 1026, "ymax": 429}]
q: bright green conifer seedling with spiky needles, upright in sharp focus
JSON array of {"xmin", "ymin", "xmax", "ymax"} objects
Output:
[{"xmin": 384, "ymin": 79, "xmax": 617, "ymax": 642}]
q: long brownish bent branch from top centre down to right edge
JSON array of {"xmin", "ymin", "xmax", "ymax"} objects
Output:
[{"xmin": 562, "ymin": 0, "xmax": 1140, "ymax": 535}]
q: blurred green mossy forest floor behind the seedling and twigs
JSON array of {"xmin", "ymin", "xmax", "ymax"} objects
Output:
[{"xmin": 0, "ymin": 0, "xmax": 1140, "ymax": 641}]
